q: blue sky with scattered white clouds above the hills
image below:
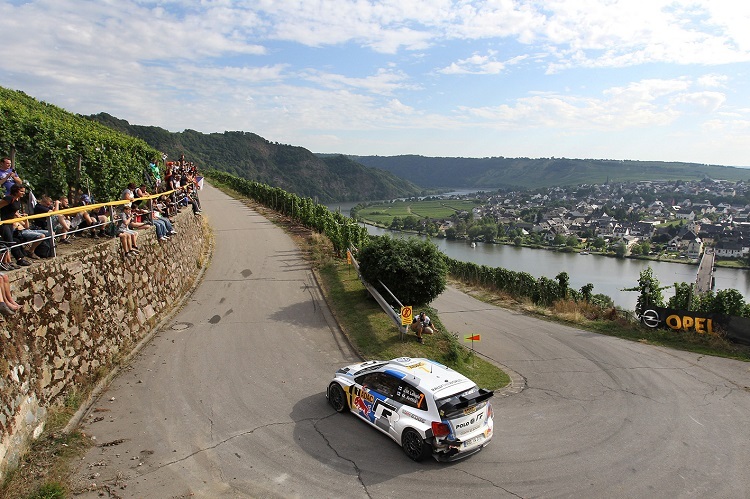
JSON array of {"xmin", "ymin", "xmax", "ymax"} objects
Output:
[{"xmin": 0, "ymin": 0, "xmax": 750, "ymax": 167}]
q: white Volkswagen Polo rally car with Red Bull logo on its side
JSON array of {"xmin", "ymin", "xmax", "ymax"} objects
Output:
[{"xmin": 326, "ymin": 357, "xmax": 493, "ymax": 461}]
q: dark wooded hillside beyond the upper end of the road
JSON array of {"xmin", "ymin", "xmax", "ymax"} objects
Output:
[{"xmin": 88, "ymin": 113, "xmax": 422, "ymax": 203}]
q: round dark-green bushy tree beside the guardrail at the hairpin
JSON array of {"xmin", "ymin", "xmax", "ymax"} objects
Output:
[{"xmin": 359, "ymin": 236, "xmax": 448, "ymax": 306}]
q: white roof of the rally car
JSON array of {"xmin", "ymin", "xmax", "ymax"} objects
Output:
[{"xmin": 381, "ymin": 357, "xmax": 476, "ymax": 398}]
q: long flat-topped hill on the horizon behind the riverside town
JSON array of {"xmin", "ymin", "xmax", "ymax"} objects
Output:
[{"xmin": 349, "ymin": 155, "xmax": 750, "ymax": 189}]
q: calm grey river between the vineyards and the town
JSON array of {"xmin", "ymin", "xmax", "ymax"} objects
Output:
[{"xmin": 329, "ymin": 203, "xmax": 750, "ymax": 310}]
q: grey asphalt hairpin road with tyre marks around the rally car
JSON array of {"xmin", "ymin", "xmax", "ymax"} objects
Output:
[{"xmin": 70, "ymin": 186, "xmax": 750, "ymax": 498}]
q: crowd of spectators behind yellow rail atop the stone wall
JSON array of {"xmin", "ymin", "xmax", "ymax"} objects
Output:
[{"xmin": 0, "ymin": 156, "xmax": 202, "ymax": 319}]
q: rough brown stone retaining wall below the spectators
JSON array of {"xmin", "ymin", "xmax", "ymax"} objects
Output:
[{"xmin": 0, "ymin": 210, "xmax": 210, "ymax": 479}]
